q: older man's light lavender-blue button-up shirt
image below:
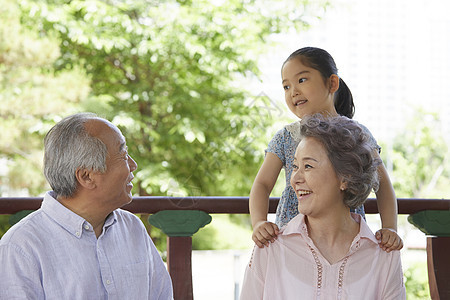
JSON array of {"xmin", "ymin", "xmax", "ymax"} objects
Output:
[{"xmin": 0, "ymin": 192, "xmax": 173, "ymax": 300}]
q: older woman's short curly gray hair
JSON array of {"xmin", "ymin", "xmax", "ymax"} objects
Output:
[{"xmin": 300, "ymin": 114, "xmax": 381, "ymax": 208}]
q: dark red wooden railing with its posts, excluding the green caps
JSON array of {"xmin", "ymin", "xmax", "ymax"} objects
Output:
[{"xmin": 0, "ymin": 196, "xmax": 450, "ymax": 300}]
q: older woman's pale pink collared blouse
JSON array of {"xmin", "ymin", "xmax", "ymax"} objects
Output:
[{"xmin": 241, "ymin": 214, "xmax": 406, "ymax": 300}]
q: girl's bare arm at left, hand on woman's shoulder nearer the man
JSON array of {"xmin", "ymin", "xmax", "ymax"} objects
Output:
[{"xmin": 249, "ymin": 152, "xmax": 283, "ymax": 248}]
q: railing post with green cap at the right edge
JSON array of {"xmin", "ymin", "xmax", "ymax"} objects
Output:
[{"xmin": 408, "ymin": 210, "xmax": 450, "ymax": 300}]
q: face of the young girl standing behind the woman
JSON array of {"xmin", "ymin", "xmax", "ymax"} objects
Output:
[{"xmin": 281, "ymin": 58, "xmax": 339, "ymax": 118}]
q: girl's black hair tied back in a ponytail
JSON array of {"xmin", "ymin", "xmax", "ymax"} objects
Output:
[{"xmin": 283, "ymin": 47, "xmax": 355, "ymax": 119}]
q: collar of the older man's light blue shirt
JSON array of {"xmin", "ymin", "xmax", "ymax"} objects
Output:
[{"xmin": 41, "ymin": 191, "xmax": 116, "ymax": 238}]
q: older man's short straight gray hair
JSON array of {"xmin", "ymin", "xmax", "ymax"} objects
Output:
[{"xmin": 44, "ymin": 113, "xmax": 108, "ymax": 197}]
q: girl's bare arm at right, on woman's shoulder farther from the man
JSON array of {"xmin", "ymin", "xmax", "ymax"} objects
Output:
[{"xmin": 375, "ymin": 153, "xmax": 403, "ymax": 252}]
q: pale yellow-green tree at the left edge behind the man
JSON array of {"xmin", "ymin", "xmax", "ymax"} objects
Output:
[{"xmin": 0, "ymin": 0, "xmax": 90, "ymax": 194}]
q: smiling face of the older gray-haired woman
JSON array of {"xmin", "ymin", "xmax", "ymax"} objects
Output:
[{"xmin": 291, "ymin": 137, "xmax": 344, "ymax": 217}]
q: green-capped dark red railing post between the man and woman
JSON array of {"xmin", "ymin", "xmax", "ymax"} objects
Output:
[{"xmin": 149, "ymin": 210, "xmax": 211, "ymax": 300}]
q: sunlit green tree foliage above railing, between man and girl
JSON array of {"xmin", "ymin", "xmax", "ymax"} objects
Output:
[{"xmin": 0, "ymin": 0, "xmax": 324, "ymax": 196}]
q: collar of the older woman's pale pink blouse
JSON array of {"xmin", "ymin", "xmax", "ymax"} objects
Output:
[{"xmin": 280, "ymin": 213, "xmax": 378, "ymax": 245}]
